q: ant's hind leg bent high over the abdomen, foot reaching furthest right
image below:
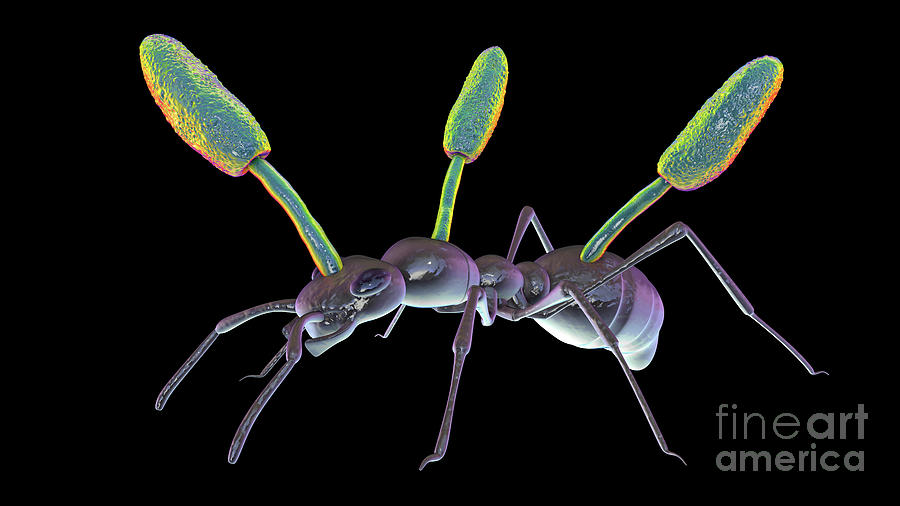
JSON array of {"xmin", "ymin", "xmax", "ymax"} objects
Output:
[{"xmin": 564, "ymin": 221, "xmax": 828, "ymax": 375}]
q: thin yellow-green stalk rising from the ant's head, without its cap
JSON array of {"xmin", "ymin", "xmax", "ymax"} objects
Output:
[{"xmin": 249, "ymin": 158, "xmax": 343, "ymax": 276}]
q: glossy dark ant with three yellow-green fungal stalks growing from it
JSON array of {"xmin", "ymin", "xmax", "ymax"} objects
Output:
[{"xmin": 140, "ymin": 34, "xmax": 827, "ymax": 470}]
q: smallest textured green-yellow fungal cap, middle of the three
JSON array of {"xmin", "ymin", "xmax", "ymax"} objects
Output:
[{"xmin": 444, "ymin": 46, "xmax": 509, "ymax": 163}]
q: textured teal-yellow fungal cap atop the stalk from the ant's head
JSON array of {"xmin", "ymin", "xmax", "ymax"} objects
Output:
[{"xmin": 140, "ymin": 34, "xmax": 271, "ymax": 176}]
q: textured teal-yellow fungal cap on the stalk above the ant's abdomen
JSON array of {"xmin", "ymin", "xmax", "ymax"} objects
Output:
[{"xmin": 657, "ymin": 56, "xmax": 784, "ymax": 190}]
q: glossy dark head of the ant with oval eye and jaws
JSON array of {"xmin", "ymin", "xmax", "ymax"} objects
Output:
[{"xmin": 295, "ymin": 255, "xmax": 406, "ymax": 357}]
